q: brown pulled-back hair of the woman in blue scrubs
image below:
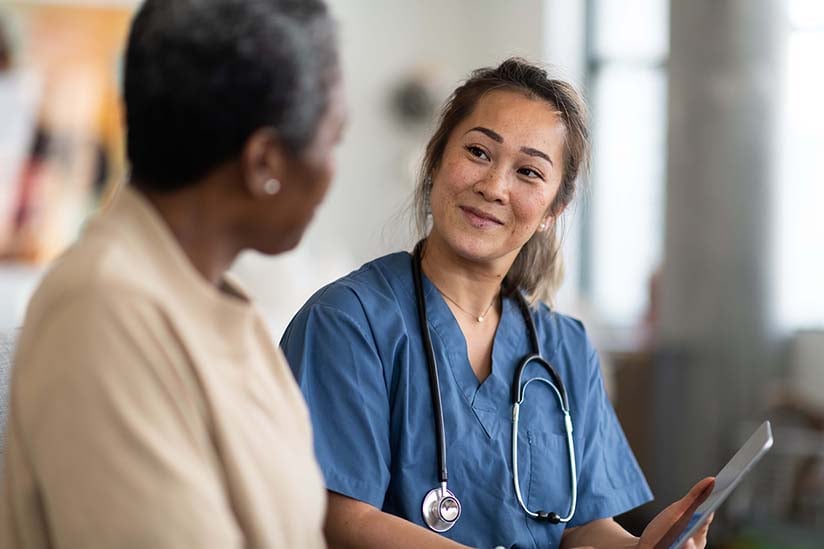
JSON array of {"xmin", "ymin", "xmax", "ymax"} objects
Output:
[{"xmin": 415, "ymin": 58, "xmax": 590, "ymax": 303}]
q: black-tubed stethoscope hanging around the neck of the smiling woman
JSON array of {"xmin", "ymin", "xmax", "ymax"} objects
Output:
[{"xmin": 412, "ymin": 241, "xmax": 578, "ymax": 532}]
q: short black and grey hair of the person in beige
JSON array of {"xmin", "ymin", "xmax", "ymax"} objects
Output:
[{"xmin": 124, "ymin": 0, "xmax": 338, "ymax": 191}]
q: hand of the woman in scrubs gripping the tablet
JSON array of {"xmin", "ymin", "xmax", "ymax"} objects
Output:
[{"xmin": 637, "ymin": 477, "xmax": 715, "ymax": 549}]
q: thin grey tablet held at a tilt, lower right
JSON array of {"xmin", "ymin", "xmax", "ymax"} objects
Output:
[{"xmin": 670, "ymin": 421, "xmax": 773, "ymax": 549}]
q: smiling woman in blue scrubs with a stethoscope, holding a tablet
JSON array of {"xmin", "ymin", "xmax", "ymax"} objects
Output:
[{"xmin": 281, "ymin": 59, "xmax": 712, "ymax": 548}]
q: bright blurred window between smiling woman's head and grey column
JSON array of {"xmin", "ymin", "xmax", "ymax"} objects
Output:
[{"xmin": 582, "ymin": 0, "xmax": 669, "ymax": 327}]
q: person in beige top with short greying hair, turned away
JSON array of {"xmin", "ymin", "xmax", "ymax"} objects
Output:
[{"xmin": 0, "ymin": 0, "xmax": 343, "ymax": 549}]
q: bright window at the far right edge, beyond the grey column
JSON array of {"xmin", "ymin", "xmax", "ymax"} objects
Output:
[{"xmin": 774, "ymin": 0, "xmax": 824, "ymax": 329}]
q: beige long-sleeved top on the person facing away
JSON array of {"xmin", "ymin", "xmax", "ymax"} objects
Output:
[{"xmin": 0, "ymin": 188, "xmax": 326, "ymax": 549}]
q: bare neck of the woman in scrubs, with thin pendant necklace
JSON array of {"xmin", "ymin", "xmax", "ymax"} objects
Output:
[{"xmin": 421, "ymin": 233, "xmax": 514, "ymax": 316}]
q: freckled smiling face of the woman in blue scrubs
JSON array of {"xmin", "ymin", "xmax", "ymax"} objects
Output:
[{"xmin": 430, "ymin": 91, "xmax": 565, "ymax": 269}]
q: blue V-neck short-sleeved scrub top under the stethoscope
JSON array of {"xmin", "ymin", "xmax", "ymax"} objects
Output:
[{"xmin": 281, "ymin": 252, "xmax": 652, "ymax": 548}]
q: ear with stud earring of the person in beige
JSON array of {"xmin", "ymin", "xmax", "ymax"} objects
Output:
[{"xmin": 240, "ymin": 128, "xmax": 287, "ymax": 199}]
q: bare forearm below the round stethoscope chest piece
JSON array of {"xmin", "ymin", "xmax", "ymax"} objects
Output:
[{"xmin": 324, "ymin": 492, "xmax": 466, "ymax": 549}]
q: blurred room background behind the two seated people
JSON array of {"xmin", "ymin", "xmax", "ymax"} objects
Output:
[{"xmin": 0, "ymin": 0, "xmax": 824, "ymax": 548}]
